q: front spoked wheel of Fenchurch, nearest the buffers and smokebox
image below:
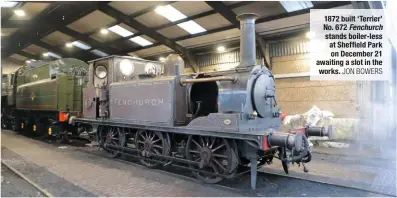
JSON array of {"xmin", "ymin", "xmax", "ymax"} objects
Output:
[{"xmin": 186, "ymin": 136, "xmax": 232, "ymax": 184}]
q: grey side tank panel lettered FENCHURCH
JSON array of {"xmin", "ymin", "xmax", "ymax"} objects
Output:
[{"xmin": 109, "ymin": 79, "xmax": 175, "ymax": 124}]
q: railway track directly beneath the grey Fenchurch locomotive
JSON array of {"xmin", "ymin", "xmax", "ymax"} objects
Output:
[{"xmin": 7, "ymin": 131, "xmax": 390, "ymax": 196}]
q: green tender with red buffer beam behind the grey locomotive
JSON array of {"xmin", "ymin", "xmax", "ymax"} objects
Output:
[{"xmin": 1, "ymin": 58, "xmax": 88, "ymax": 138}]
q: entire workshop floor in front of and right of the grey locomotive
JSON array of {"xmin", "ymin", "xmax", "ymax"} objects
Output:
[{"xmin": 1, "ymin": 130, "xmax": 395, "ymax": 197}]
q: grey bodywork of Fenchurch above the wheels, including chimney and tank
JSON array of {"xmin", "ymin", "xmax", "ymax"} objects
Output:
[{"xmin": 76, "ymin": 12, "xmax": 281, "ymax": 146}]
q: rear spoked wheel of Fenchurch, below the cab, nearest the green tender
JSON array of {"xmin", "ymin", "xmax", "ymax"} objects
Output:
[{"xmin": 98, "ymin": 127, "xmax": 125, "ymax": 158}]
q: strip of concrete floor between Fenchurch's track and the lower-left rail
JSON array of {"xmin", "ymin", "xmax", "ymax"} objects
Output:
[{"xmin": 1, "ymin": 130, "xmax": 392, "ymax": 197}]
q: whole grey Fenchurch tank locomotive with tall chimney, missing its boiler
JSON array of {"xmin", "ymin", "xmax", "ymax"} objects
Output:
[{"xmin": 75, "ymin": 14, "xmax": 326, "ymax": 188}]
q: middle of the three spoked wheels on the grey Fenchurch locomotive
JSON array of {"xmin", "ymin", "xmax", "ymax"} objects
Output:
[{"xmin": 135, "ymin": 130, "xmax": 169, "ymax": 168}]
